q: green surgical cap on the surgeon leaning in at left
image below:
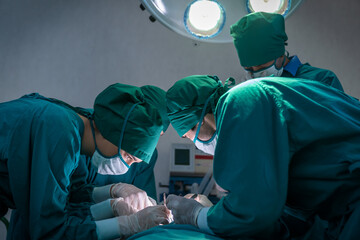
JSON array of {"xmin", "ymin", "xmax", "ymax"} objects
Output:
[{"xmin": 94, "ymin": 83, "xmax": 163, "ymax": 163}]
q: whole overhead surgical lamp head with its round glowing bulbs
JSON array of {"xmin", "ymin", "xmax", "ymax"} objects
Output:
[{"xmin": 140, "ymin": 0, "xmax": 302, "ymax": 43}]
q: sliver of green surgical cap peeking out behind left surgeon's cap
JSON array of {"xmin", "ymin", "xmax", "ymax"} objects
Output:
[{"xmin": 141, "ymin": 85, "xmax": 170, "ymax": 132}]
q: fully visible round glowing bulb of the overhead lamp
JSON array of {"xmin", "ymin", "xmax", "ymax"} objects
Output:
[{"xmin": 184, "ymin": 0, "xmax": 225, "ymax": 38}]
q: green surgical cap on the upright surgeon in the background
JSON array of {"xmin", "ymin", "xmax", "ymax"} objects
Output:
[{"xmin": 230, "ymin": 12, "xmax": 288, "ymax": 67}]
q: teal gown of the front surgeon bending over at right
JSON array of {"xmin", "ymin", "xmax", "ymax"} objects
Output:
[{"xmin": 207, "ymin": 77, "xmax": 360, "ymax": 239}]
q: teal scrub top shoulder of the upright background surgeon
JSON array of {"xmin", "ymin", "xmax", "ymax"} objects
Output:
[{"xmin": 281, "ymin": 55, "xmax": 344, "ymax": 91}]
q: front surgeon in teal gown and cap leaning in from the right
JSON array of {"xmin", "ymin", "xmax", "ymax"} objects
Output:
[{"xmin": 166, "ymin": 75, "xmax": 360, "ymax": 240}]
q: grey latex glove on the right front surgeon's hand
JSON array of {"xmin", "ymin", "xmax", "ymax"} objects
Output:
[{"xmin": 166, "ymin": 195, "xmax": 204, "ymax": 226}]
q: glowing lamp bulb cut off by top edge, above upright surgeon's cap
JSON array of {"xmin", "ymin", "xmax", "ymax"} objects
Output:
[{"xmin": 247, "ymin": 0, "xmax": 291, "ymax": 16}]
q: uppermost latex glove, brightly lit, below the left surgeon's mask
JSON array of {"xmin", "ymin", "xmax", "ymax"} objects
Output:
[{"xmin": 110, "ymin": 183, "xmax": 154, "ymax": 211}]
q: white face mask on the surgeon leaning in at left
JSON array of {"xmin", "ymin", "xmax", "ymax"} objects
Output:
[{"xmin": 91, "ymin": 150, "xmax": 129, "ymax": 175}]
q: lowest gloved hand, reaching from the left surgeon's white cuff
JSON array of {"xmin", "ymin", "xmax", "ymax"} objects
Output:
[{"xmin": 118, "ymin": 205, "xmax": 170, "ymax": 238}]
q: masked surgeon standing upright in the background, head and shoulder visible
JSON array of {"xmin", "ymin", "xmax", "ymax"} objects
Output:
[{"xmin": 230, "ymin": 12, "xmax": 343, "ymax": 91}]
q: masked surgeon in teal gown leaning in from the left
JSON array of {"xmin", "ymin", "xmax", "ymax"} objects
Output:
[{"xmin": 0, "ymin": 83, "xmax": 168, "ymax": 239}]
